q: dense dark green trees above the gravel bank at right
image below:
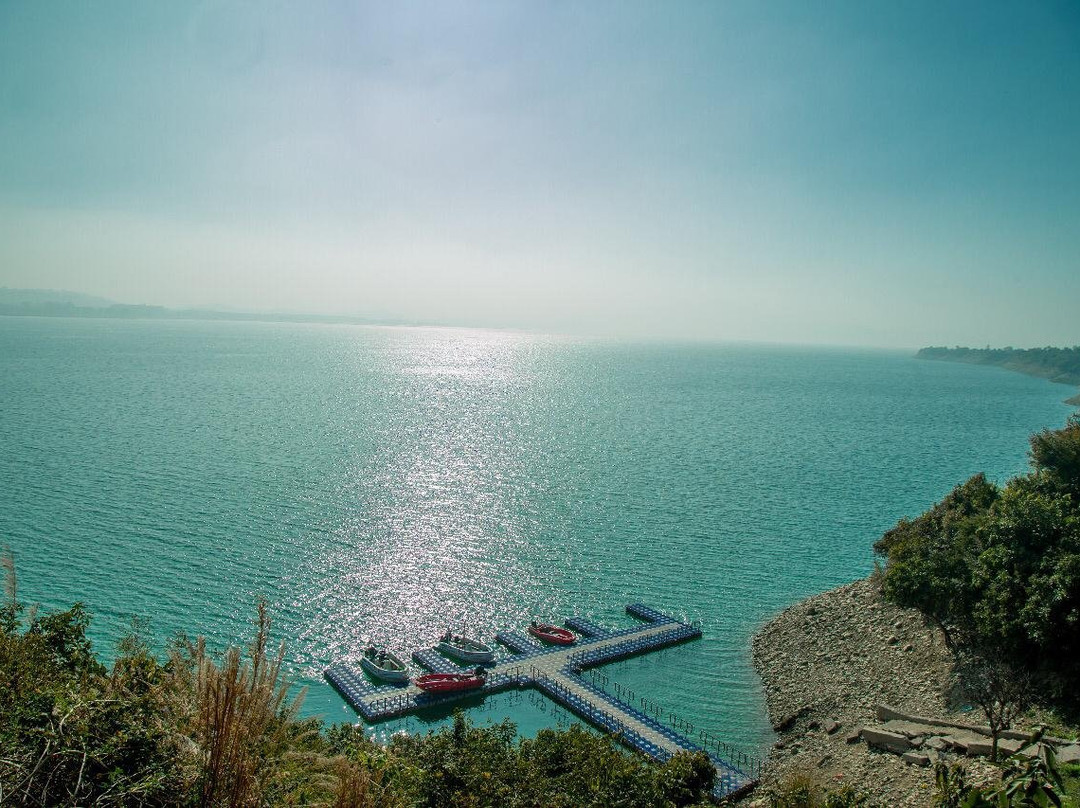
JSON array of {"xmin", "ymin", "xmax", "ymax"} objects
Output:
[{"xmin": 875, "ymin": 415, "xmax": 1080, "ymax": 756}]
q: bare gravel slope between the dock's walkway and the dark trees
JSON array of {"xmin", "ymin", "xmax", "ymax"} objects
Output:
[{"xmin": 747, "ymin": 579, "xmax": 991, "ymax": 806}]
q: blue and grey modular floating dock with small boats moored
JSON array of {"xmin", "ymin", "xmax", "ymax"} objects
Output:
[{"xmin": 325, "ymin": 603, "xmax": 756, "ymax": 798}]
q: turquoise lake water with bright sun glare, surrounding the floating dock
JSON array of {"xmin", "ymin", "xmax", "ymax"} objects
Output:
[{"xmin": 0, "ymin": 318, "xmax": 1072, "ymax": 750}]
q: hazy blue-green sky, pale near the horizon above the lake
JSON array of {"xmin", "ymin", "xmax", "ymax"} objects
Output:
[{"xmin": 0, "ymin": 0, "xmax": 1080, "ymax": 347}]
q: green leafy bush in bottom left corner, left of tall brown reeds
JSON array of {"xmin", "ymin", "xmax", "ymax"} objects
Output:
[{"xmin": 0, "ymin": 604, "xmax": 181, "ymax": 806}]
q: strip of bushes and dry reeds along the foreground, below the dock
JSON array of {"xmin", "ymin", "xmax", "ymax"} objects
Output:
[{"xmin": 0, "ymin": 556, "xmax": 715, "ymax": 808}]
